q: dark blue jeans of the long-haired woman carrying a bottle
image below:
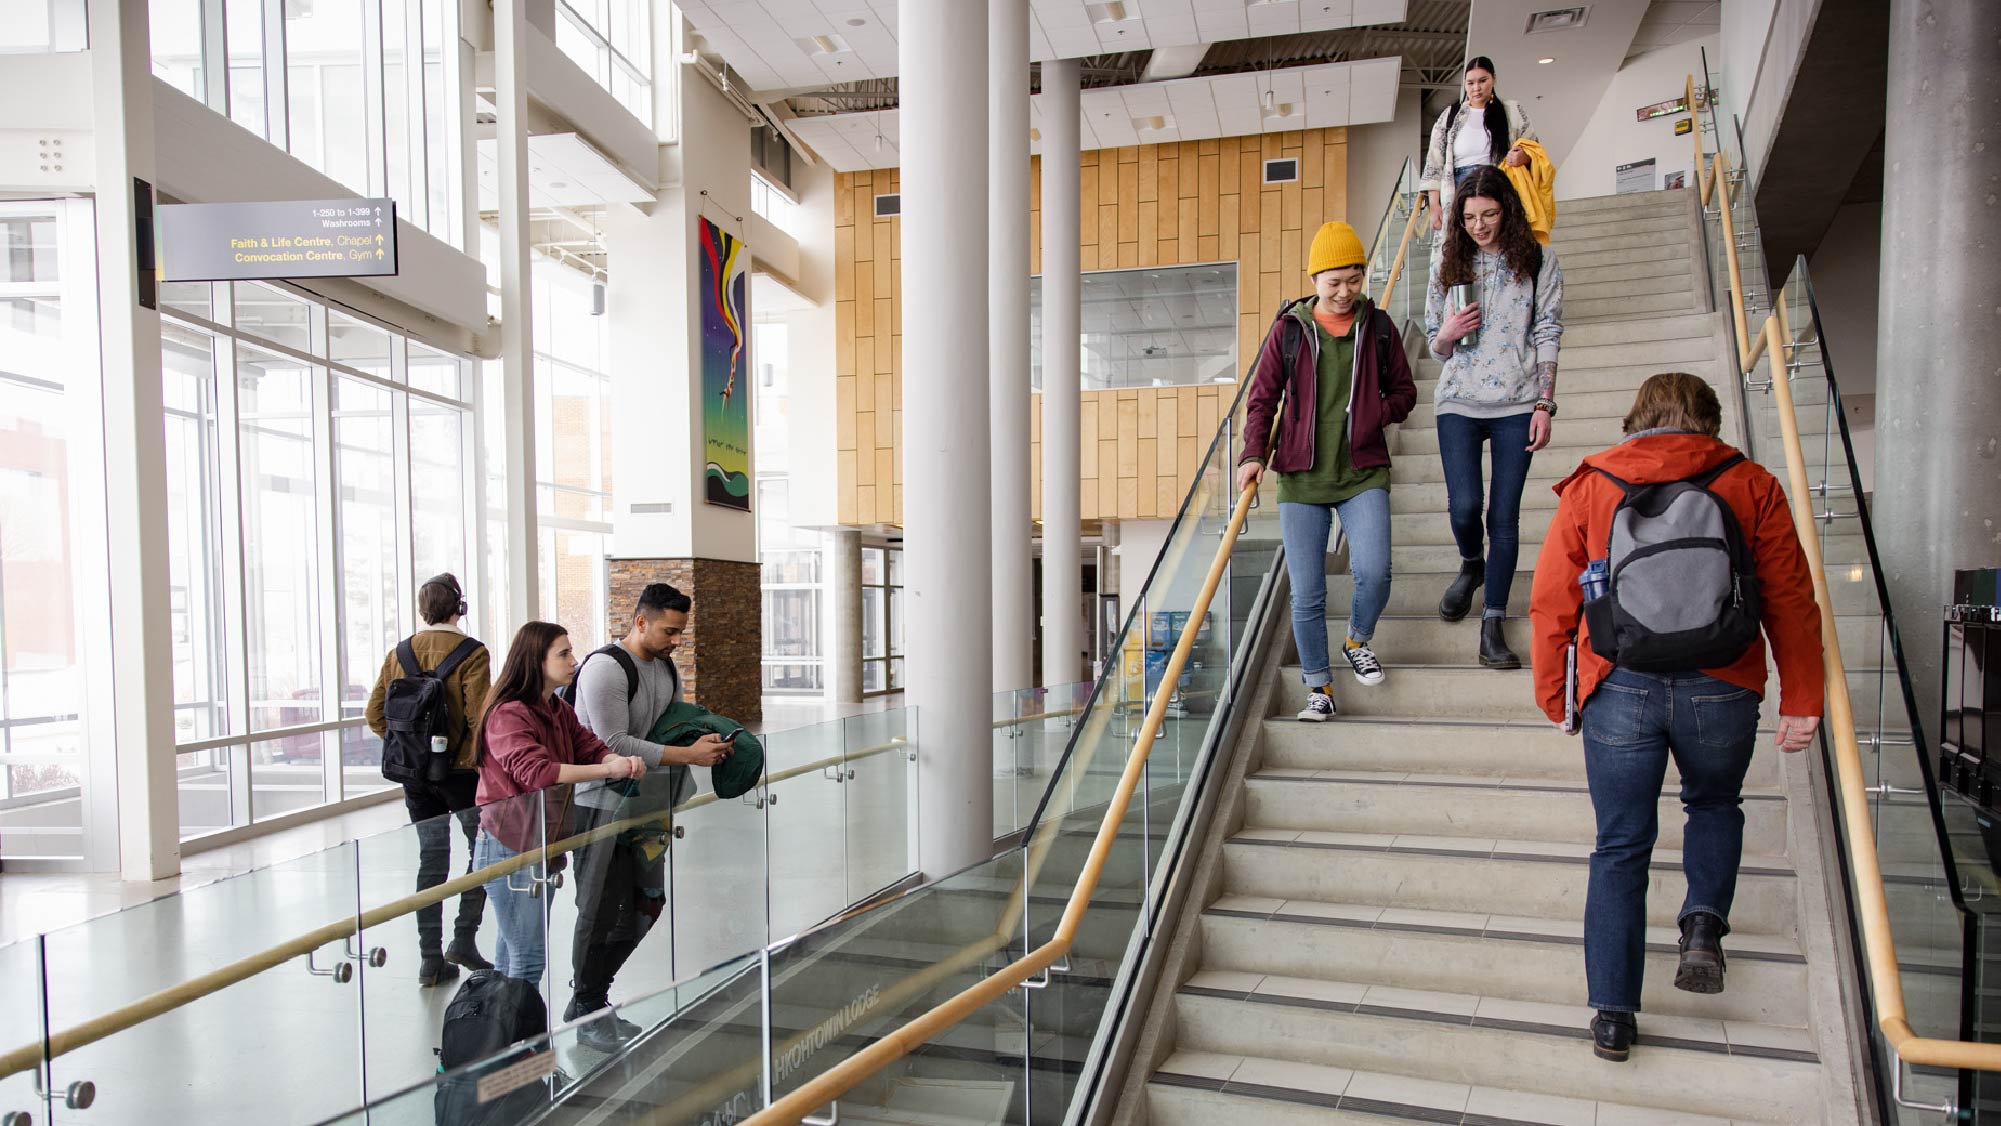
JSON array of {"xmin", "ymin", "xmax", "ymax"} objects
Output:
[{"xmin": 1439, "ymin": 412, "xmax": 1535, "ymax": 614}]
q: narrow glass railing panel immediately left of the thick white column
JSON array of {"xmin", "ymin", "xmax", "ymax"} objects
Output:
[{"xmin": 840, "ymin": 708, "xmax": 918, "ymax": 904}]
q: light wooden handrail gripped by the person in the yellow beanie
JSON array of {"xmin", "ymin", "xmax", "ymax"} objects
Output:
[{"xmin": 744, "ymin": 196, "xmax": 1425, "ymax": 1126}]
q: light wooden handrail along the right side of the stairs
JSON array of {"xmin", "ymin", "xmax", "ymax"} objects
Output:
[{"xmin": 1689, "ymin": 74, "xmax": 2001, "ymax": 1080}]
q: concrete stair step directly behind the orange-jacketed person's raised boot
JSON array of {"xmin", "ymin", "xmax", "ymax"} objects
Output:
[{"xmin": 1203, "ymin": 894, "xmax": 1807, "ymax": 1026}]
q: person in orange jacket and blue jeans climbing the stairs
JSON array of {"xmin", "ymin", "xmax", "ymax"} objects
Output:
[{"xmin": 1529, "ymin": 372, "xmax": 1825, "ymax": 1060}]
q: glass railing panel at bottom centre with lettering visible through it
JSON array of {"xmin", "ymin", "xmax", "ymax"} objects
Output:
[{"xmin": 770, "ymin": 850, "xmax": 1025, "ymax": 1122}]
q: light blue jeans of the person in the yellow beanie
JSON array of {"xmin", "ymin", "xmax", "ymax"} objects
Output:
[{"xmin": 1279, "ymin": 488, "xmax": 1389, "ymax": 688}]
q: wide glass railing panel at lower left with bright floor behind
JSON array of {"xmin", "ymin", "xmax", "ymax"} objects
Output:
[{"xmin": 44, "ymin": 844, "xmax": 370, "ymax": 1124}]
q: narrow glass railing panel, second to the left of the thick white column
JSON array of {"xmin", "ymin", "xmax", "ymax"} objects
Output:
[{"xmin": 764, "ymin": 720, "xmax": 852, "ymax": 940}]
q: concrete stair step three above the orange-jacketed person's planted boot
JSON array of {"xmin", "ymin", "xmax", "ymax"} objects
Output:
[{"xmin": 1245, "ymin": 766, "xmax": 1785, "ymax": 856}]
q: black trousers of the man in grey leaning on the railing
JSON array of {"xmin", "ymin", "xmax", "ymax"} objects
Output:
[{"xmin": 566, "ymin": 806, "xmax": 666, "ymax": 1020}]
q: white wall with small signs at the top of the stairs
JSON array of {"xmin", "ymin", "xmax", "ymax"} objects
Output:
[{"xmin": 1531, "ymin": 36, "xmax": 1717, "ymax": 204}]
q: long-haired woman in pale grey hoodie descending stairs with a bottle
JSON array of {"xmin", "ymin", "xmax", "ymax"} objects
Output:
[{"xmin": 1425, "ymin": 166, "xmax": 1563, "ymax": 668}]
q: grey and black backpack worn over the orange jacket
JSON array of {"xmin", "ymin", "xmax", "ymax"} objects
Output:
[{"xmin": 1585, "ymin": 454, "xmax": 1761, "ymax": 672}]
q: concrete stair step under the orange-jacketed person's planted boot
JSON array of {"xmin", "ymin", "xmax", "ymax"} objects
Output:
[{"xmin": 1175, "ymin": 976, "xmax": 1821, "ymax": 1122}]
